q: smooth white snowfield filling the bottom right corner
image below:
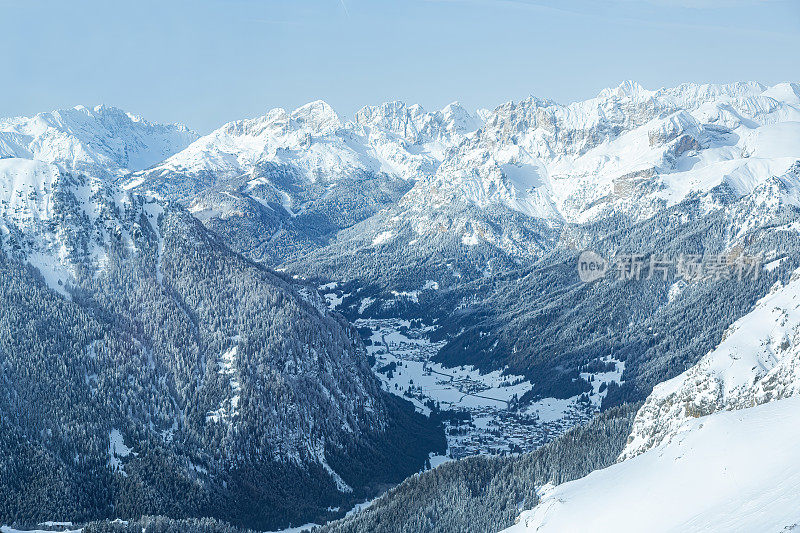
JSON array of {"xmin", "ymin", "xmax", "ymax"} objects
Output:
[{"xmin": 506, "ymin": 398, "xmax": 800, "ymax": 533}]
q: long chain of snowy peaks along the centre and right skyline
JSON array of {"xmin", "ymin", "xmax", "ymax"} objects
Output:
[{"xmin": 124, "ymin": 82, "xmax": 800, "ymax": 274}]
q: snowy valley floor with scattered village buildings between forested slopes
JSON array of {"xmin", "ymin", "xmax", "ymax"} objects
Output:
[{"xmin": 344, "ymin": 308, "xmax": 625, "ymax": 459}]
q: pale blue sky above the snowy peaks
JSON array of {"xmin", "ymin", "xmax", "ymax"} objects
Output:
[{"xmin": 0, "ymin": 0, "xmax": 800, "ymax": 133}]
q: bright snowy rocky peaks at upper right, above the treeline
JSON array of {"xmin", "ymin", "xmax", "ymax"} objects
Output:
[{"xmin": 412, "ymin": 82, "xmax": 800, "ymax": 227}]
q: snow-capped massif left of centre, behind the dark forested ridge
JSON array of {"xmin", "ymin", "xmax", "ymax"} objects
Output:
[{"xmin": 123, "ymin": 102, "xmax": 473, "ymax": 264}]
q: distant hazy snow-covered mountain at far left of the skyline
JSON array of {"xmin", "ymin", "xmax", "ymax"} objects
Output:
[{"xmin": 0, "ymin": 105, "xmax": 197, "ymax": 176}]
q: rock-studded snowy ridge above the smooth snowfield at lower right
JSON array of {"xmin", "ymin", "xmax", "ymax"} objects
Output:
[{"xmin": 622, "ymin": 271, "xmax": 800, "ymax": 459}]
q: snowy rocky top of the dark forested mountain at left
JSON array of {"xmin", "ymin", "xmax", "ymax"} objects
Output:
[{"xmin": 0, "ymin": 154, "xmax": 162, "ymax": 298}]
